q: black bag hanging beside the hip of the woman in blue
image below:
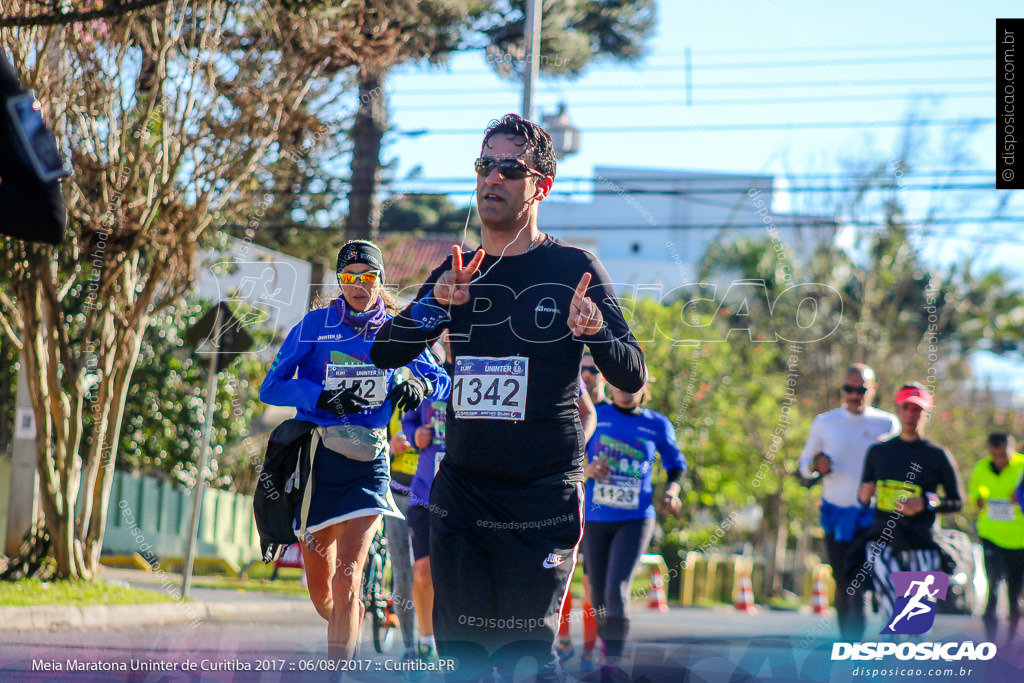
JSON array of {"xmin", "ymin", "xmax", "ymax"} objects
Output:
[{"xmin": 253, "ymin": 419, "xmax": 316, "ymax": 564}]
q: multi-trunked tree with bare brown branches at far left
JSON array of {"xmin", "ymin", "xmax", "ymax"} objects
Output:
[{"xmin": 0, "ymin": 0, "xmax": 395, "ymax": 578}]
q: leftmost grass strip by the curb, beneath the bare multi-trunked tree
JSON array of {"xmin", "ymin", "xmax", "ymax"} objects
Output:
[{"xmin": 0, "ymin": 579, "xmax": 172, "ymax": 606}]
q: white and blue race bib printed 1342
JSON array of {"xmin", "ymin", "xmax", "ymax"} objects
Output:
[{"xmin": 452, "ymin": 356, "xmax": 528, "ymax": 420}]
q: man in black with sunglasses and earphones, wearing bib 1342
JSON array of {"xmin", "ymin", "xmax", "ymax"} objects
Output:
[{"xmin": 371, "ymin": 114, "xmax": 646, "ymax": 679}]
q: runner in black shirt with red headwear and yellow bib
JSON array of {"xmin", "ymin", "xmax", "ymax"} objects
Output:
[{"xmin": 855, "ymin": 383, "xmax": 964, "ymax": 625}]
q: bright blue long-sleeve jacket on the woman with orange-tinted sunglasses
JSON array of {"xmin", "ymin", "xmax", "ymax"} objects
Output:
[{"xmin": 259, "ymin": 306, "xmax": 452, "ymax": 428}]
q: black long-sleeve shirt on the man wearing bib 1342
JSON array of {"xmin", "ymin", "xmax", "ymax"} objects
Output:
[{"xmin": 370, "ymin": 238, "xmax": 646, "ymax": 481}]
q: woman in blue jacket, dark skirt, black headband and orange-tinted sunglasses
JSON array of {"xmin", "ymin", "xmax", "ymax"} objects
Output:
[{"xmin": 260, "ymin": 241, "xmax": 452, "ymax": 659}]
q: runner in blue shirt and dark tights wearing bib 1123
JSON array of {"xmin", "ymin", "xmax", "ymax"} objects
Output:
[{"xmin": 583, "ymin": 386, "xmax": 686, "ymax": 665}]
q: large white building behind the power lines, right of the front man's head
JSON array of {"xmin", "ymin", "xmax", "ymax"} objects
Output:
[{"xmin": 541, "ymin": 167, "xmax": 837, "ymax": 291}]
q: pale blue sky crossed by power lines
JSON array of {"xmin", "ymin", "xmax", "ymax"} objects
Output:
[{"xmin": 366, "ymin": 0, "xmax": 1024, "ymax": 383}]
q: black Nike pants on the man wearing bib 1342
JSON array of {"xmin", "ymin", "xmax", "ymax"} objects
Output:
[{"xmin": 430, "ymin": 460, "xmax": 583, "ymax": 680}]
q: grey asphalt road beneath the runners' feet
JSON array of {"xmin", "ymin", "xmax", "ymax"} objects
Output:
[{"xmin": 0, "ymin": 605, "xmax": 1024, "ymax": 683}]
